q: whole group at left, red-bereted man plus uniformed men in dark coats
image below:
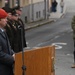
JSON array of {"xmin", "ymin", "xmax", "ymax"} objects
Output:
[{"xmin": 0, "ymin": 6, "xmax": 27, "ymax": 75}]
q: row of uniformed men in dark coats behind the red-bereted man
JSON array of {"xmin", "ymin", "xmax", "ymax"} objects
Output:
[{"xmin": 2, "ymin": 6, "xmax": 27, "ymax": 52}]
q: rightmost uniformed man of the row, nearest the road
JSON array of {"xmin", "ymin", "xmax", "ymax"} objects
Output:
[{"xmin": 13, "ymin": 6, "xmax": 27, "ymax": 49}]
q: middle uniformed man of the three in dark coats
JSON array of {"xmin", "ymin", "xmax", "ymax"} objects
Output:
[{"xmin": 11, "ymin": 10, "xmax": 21, "ymax": 53}]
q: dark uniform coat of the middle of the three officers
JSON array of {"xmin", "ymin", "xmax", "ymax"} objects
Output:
[{"xmin": 13, "ymin": 21, "xmax": 21, "ymax": 53}]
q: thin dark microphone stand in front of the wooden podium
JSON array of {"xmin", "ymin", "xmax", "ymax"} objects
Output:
[{"xmin": 18, "ymin": 25, "xmax": 26, "ymax": 75}]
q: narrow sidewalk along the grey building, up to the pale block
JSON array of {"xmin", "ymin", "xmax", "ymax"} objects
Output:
[{"xmin": 25, "ymin": 12, "xmax": 63, "ymax": 30}]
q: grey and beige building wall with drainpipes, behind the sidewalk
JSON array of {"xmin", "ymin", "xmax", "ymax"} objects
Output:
[{"xmin": 22, "ymin": 0, "xmax": 51, "ymax": 23}]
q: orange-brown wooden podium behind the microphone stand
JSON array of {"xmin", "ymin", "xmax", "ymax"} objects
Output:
[{"xmin": 14, "ymin": 46, "xmax": 55, "ymax": 75}]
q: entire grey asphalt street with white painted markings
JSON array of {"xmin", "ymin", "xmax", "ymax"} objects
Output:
[{"xmin": 26, "ymin": 0, "xmax": 75, "ymax": 75}]
